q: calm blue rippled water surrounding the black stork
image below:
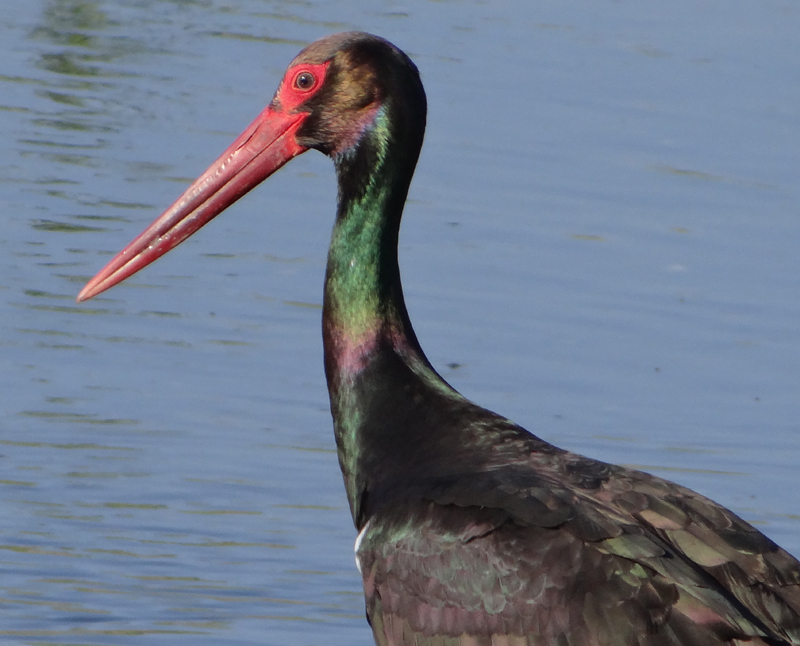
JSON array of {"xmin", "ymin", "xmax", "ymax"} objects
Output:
[{"xmin": 0, "ymin": 0, "xmax": 800, "ymax": 645}]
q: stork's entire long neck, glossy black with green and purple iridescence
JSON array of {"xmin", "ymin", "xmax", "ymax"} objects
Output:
[{"xmin": 323, "ymin": 110, "xmax": 460, "ymax": 524}]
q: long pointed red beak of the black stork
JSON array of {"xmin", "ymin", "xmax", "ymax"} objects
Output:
[{"xmin": 77, "ymin": 107, "xmax": 308, "ymax": 302}]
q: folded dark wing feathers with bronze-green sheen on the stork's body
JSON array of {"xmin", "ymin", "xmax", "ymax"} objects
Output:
[{"xmin": 359, "ymin": 454, "xmax": 800, "ymax": 646}]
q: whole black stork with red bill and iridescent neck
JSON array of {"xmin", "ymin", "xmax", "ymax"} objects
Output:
[{"xmin": 78, "ymin": 33, "xmax": 800, "ymax": 646}]
